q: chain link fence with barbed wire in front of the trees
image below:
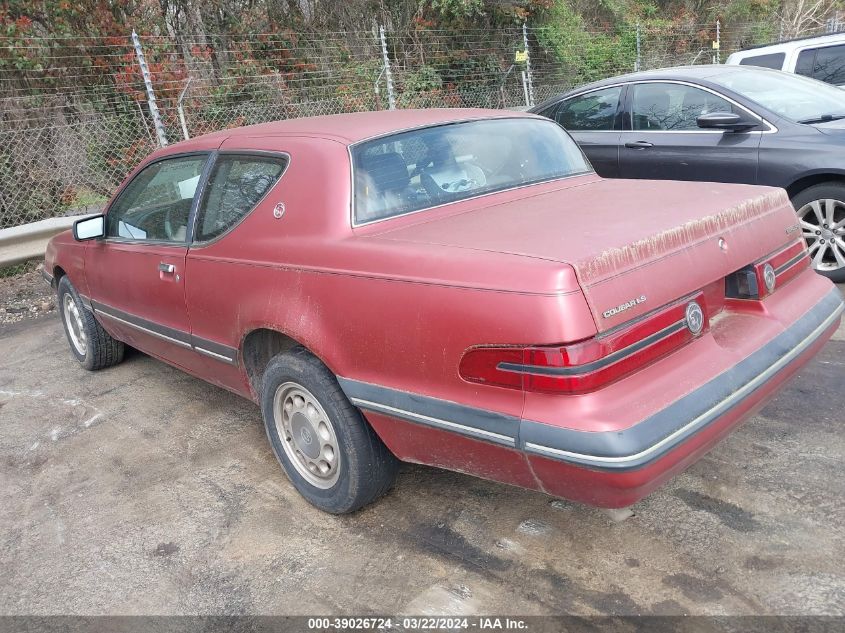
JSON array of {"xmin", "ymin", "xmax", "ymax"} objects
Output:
[{"xmin": 0, "ymin": 23, "xmax": 840, "ymax": 229}]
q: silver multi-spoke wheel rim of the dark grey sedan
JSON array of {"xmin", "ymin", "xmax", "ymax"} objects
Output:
[{"xmin": 798, "ymin": 198, "xmax": 845, "ymax": 272}]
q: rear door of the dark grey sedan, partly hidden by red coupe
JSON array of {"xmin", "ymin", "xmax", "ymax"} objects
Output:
[{"xmin": 542, "ymin": 86, "xmax": 623, "ymax": 178}]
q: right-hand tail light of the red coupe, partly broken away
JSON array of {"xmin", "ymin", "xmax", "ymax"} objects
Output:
[{"xmin": 725, "ymin": 242, "xmax": 810, "ymax": 301}]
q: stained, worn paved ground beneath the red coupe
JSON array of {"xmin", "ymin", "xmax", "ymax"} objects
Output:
[{"xmin": 0, "ymin": 284, "xmax": 845, "ymax": 615}]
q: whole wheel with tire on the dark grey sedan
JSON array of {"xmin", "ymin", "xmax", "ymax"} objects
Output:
[{"xmin": 792, "ymin": 182, "xmax": 845, "ymax": 283}]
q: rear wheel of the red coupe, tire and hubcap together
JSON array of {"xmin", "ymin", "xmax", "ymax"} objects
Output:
[{"xmin": 261, "ymin": 347, "xmax": 399, "ymax": 514}]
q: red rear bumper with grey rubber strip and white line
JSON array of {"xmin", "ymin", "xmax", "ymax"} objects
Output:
[{"xmin": 520, "ymin": 289, "xmax": 845, "ymax": 507}]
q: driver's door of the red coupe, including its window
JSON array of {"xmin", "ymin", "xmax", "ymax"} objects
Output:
[{"xmin": 85, "ymin": 153, "xmax": 209, "ymax": 369}]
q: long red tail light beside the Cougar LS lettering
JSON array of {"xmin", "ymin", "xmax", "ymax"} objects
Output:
[{"xmin": 459, "ymin": 293, "xmax": 707, "ymax": 393}]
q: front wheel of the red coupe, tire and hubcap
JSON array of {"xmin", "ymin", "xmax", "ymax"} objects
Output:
[{"xmin": 58, "ymin": 276, "xmax": 126, "ymax": 371}]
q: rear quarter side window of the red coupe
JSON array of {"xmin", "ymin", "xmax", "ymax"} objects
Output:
[{"xmin": 194, "ymin": 155, "xmax": 288, "ymax": 242}]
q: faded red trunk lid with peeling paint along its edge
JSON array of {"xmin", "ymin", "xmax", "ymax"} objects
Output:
[{"xmin": 378, "ymin": 180, "xmax": 800, "ymax": 332}]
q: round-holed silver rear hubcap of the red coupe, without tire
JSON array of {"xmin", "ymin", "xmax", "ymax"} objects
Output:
[{"xmin": 273, "ymin": 382, "xmax": 340, "ymax": 489}]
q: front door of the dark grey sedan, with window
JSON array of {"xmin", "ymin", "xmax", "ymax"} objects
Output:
[{"xmin": 619, "ymin": 82, "xmax": 763, "ymax": 184}]
